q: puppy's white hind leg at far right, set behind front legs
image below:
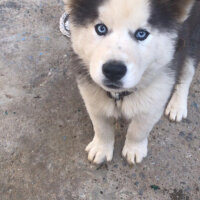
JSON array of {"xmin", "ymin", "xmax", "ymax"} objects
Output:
[{"xmin": 165, "ymin": 58, "xmax": 195, "ymax": 122}]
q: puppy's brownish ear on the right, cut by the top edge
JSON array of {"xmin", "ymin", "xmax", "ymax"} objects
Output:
[{"xmin": 170, "ymin": 0, "xmax": 196, "ymax": 23}]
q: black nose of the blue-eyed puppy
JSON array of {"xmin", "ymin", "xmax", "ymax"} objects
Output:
[{"xmin": 103, "ymin": 61, "xmax": 127, "ymax": 82}]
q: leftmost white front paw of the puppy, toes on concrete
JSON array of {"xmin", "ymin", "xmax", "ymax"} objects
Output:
[{"xmin": 85, "ymin": 138, "xmax": 114, "ymax": 164}]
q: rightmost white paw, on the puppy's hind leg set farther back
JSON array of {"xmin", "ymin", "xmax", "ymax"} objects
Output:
[{"xmin": 165, "ymin": 92, "xmax": 187, "ymax": 122}]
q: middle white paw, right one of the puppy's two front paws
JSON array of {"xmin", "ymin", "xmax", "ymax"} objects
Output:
[{"xmin": 122, "ymin": 139, "xmax": 148, "ymax": 165}]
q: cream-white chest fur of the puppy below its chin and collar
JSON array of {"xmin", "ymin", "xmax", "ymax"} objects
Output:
[{"xmin": 78, "ymin": 70, "xmax": 175, "ymax": 119}]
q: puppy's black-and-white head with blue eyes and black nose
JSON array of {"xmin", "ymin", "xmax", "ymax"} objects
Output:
[{"xmin": 66, "ymin": 0, "xmax": 194, "ymax": 91}]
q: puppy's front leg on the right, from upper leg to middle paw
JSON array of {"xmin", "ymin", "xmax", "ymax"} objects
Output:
[{"xmin": 122, "ymin": 112, "xmax": 162, "ymax": 165}]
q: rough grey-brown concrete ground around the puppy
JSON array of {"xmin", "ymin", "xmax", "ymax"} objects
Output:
[{"xmin": 0, "ymin": 0, "xmax": 200, "ymax": 200}]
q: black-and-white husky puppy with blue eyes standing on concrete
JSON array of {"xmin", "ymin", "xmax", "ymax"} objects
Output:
[{"xmin": 65, "ymin": 0, "xmax": 200, "ymax": 164}]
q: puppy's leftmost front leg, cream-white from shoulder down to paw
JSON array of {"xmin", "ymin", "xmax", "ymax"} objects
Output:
[{"xmin": 79, "ymin": 85, "xmax": 114, "ymax": 164}]
